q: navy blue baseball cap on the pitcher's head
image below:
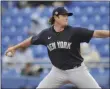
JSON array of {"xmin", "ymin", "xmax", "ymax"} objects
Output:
[{"xmin": 52, "ymin": 7, "xmax": 73, "ymax": 16}]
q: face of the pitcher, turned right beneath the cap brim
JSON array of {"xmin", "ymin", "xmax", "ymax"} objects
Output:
[{"xmin": 55, "ymin": 14, "xmax": 68, "ymax": 26}]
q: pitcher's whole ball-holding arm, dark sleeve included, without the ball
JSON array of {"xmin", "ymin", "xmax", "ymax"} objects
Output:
[{"xmin": 6, "ymin": 31, "xmax": 45, "ymax": 56}]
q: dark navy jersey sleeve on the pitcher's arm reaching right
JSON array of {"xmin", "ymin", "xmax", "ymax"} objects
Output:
[{"xmin": 76, "ymin": 28, "xmax": 94, "ymax": 43}]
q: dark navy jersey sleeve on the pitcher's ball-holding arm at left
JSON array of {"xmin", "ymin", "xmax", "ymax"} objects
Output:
[{"xmin": 31, "ymin": 31, "xmax": 45, "ymax": 45}]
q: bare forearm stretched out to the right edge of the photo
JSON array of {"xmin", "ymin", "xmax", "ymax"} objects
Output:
[{"xmin": 93, "ymin": 30, "xmax": 110, "ymax": 38}]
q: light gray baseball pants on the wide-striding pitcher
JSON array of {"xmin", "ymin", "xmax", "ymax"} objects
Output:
[{"xmin": 36, "ymin": 63, "xmax": 101, "ymax": 89}]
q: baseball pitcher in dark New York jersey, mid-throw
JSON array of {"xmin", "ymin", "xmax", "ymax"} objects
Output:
[{"xmin": 6, "ymin": 7, "xmax": 110, "ymax": 89}]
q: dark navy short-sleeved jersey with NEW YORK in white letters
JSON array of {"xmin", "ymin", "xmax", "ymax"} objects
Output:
[{"xmin": 31, "ymin": 25, "xmax": 94, "ymax": 70}]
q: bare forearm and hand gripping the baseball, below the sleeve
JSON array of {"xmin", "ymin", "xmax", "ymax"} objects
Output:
[{"xmin": 6, "ymin": 37, "xmax": 32, "ymax": 55}]
